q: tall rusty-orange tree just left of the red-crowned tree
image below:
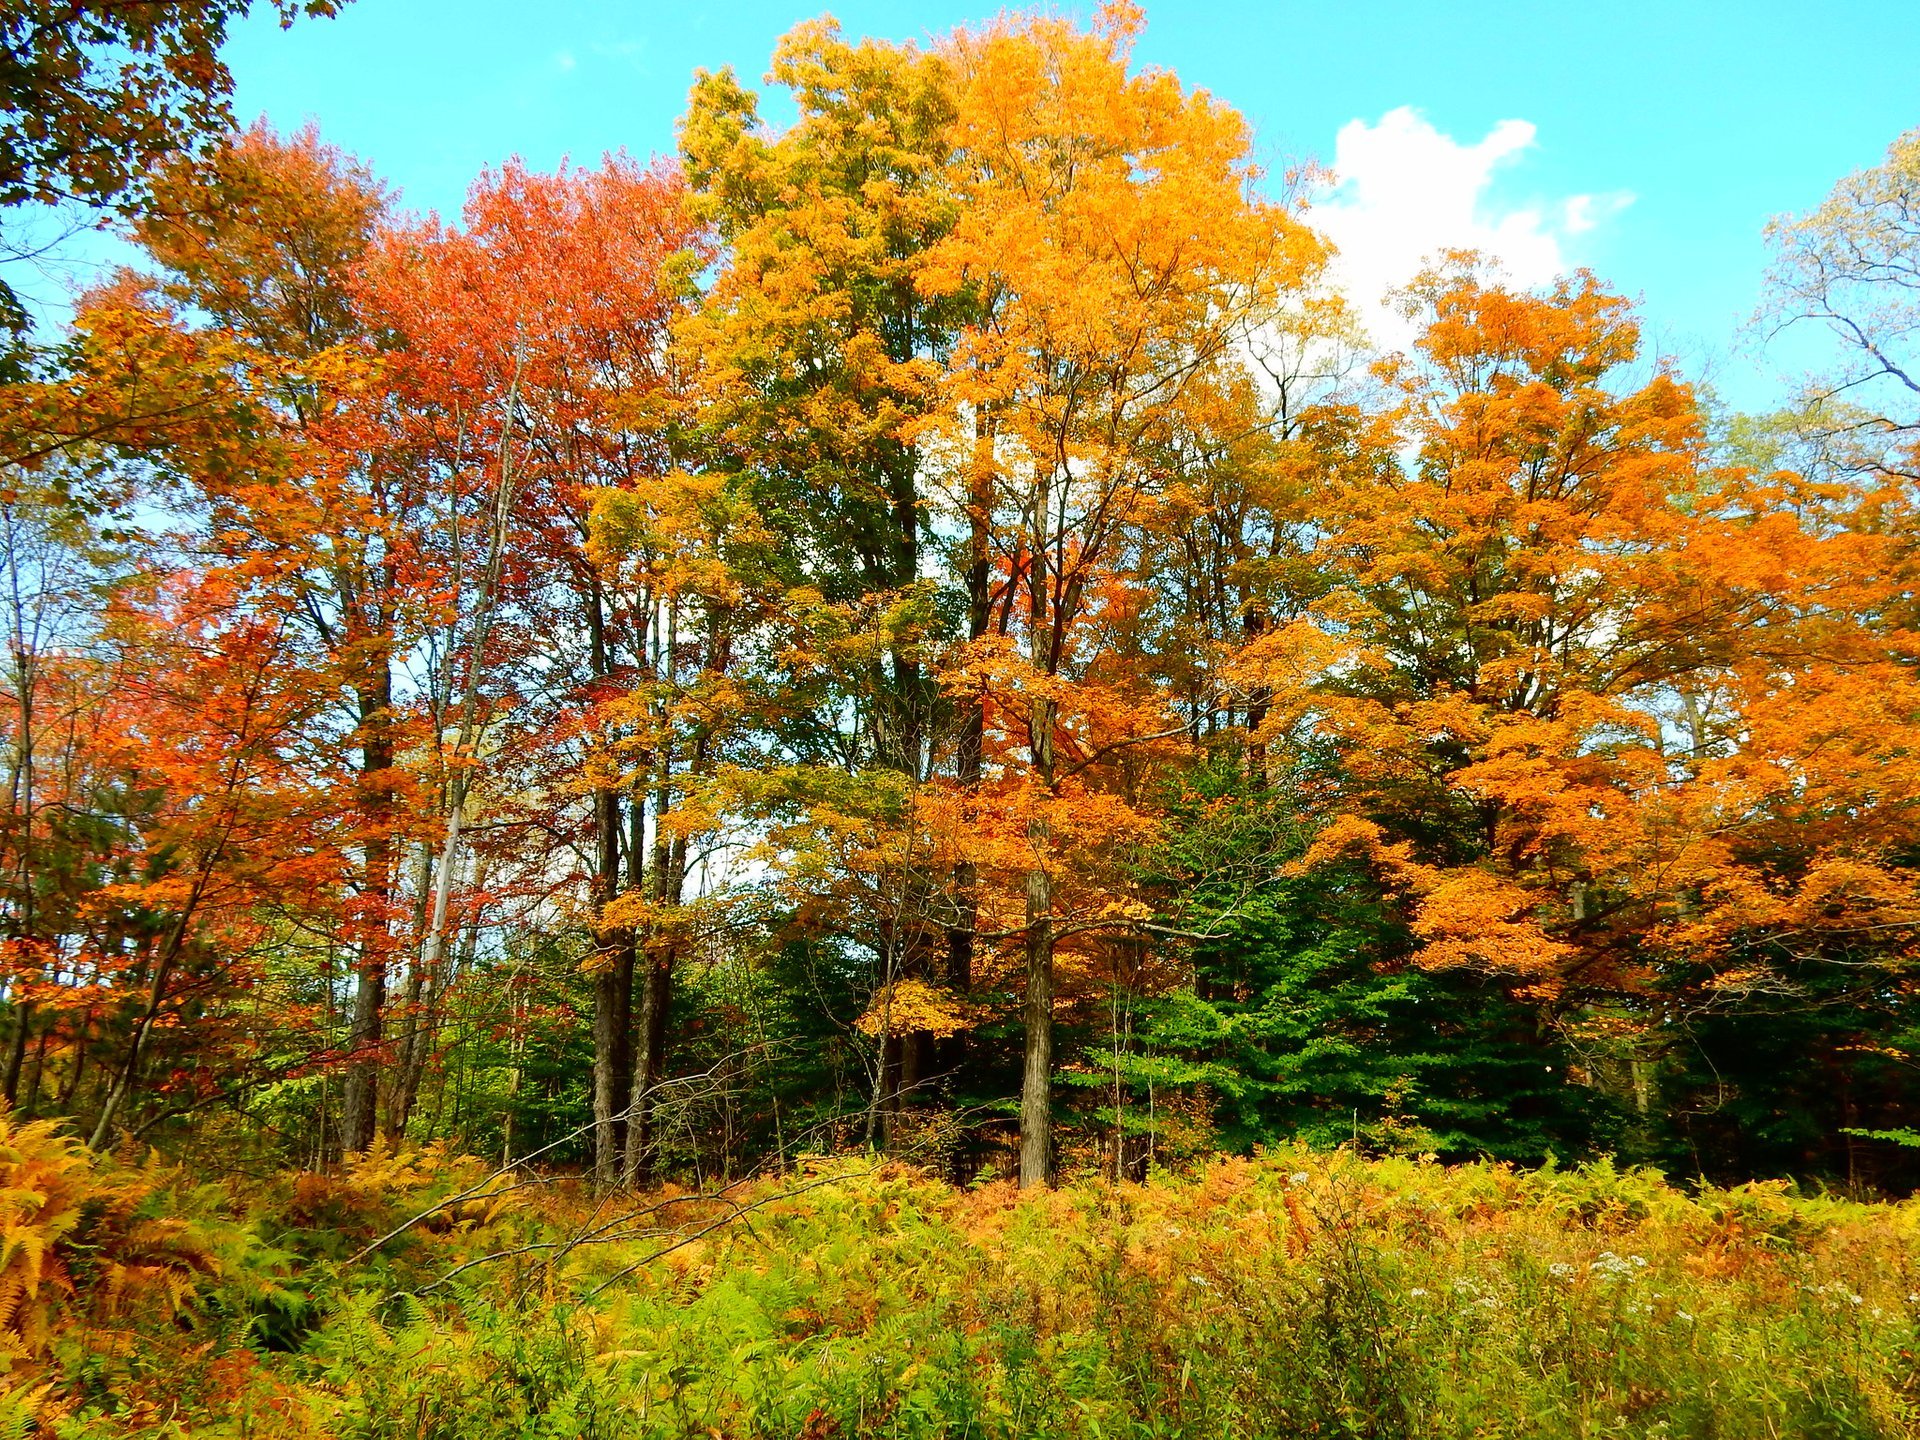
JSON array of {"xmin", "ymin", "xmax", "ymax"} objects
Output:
[{"xmin": 119, "ymin": 129, "xmax": 424, "ymax": 1150}]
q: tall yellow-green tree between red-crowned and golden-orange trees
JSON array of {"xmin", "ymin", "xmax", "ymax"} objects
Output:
[{"xmin": 678, "ymin": 21, "xmax": 985, "ymax": 1152}]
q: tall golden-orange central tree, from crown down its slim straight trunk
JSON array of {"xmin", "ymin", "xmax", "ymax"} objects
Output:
[{"xmin": 920, "ymin": 6, "xmax": 1325, "ymax": 1185}]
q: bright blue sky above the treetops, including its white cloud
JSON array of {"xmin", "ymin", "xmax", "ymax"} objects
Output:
[{"xmin": 206, "ymin": 0, "xmax": 1920, "ymax": 407}]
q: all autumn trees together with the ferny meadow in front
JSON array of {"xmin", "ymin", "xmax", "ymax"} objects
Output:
[{"xmin": 18, "ymin": 0, "xmax": 1920, "ymax": 1440}]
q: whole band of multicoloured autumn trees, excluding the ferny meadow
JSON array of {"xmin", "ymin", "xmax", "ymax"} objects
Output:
[{"xmin": 11, "ymin": 4, "xmax": 1920, "ymax": 1192}]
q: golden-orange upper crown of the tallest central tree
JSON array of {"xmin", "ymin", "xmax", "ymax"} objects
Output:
[{"xmin": 920, "ymin": 0, "xmax": 1325, "ymax": 492}]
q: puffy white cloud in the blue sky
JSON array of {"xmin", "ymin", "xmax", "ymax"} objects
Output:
[{"xmin": 1311, "ymin": 106, "xmax": 1632, "ymax": 348}]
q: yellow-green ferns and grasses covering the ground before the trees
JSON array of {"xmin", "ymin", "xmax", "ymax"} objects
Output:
[{"xmin": 0, "ymin": 1121, "xmax": 1920, "ymax": 1440}]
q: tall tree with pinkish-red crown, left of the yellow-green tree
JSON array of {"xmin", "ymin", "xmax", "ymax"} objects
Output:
[{"xmin": 378, "ymin": 157, "xmax": 708, "ymax": 1185}]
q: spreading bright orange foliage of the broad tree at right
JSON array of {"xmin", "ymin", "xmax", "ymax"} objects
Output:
[{"xmin": 1242, "ymin": 269, "xmax": 1920, "ymax": 993}]
